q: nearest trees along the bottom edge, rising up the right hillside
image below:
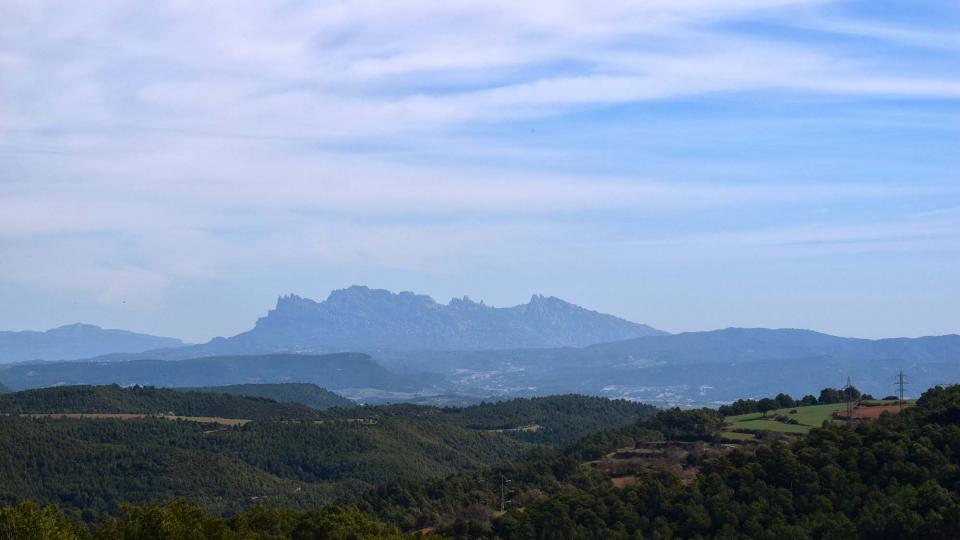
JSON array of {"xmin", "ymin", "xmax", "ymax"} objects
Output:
[{"xmin": 0, "ymin": 386, "xmax": 960, "ymax": 540}]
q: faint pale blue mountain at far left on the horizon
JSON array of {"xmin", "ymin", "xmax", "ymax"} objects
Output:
[{"xmin": 0, "ymin": 324, "xmax": 184, "ymax": 363}]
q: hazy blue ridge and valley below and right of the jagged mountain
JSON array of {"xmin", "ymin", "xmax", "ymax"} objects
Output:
[{"xmin": 378, "ymin": 328, "xmax": 960, "ymax": 405}]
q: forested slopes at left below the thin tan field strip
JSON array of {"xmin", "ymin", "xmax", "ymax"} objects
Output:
[{"xmin": 0, "ymin": 417, "xmax": 524, "ymax": 514}]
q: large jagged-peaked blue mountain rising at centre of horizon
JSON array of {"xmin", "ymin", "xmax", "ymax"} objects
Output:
[{"xmin": 196, "ymin": 286, "xmax": 664, "ymax": 354}]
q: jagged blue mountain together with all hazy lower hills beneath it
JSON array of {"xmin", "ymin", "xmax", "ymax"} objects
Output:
[{"xmin": 0, "ymin": 286, "xmax": 960, "ymax": 405}]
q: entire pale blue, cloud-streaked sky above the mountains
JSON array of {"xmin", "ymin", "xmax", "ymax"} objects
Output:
[{"xmin": 0, "ymin": 0, "xmax": 960, "ymax": 342}]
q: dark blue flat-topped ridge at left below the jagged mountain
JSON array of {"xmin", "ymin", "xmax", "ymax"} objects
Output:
[{"xmin": 0, "ymin": 353, "xmax": 411, "ymax": 390}]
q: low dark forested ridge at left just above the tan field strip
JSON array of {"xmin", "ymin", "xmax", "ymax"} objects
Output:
[{"xmin": 0, "ymin": 385, "xmax": 320, "ymax": 420}]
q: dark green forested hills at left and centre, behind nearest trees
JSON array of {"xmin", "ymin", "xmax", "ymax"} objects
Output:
[{"xmin": 0, "ymin": 386, "xmax": 652, "ymax": 519}]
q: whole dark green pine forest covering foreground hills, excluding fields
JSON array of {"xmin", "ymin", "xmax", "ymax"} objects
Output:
[{"xmin": 0, "ymin": 386, "xmax": 960, "ymax": 539}]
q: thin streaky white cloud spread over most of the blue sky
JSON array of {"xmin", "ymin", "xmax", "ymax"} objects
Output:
[{"xmin": 0, "ymin": 0, "xmax": 960, "ymax": 338}]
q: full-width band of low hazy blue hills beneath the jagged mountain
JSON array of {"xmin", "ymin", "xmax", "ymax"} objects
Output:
[{"xmin": 0, "ymin": 328, "xmax": 960, "ymax": 406}]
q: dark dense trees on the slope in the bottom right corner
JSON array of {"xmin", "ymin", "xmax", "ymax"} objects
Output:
[{"xmin": 490, "ymin": 386, "xmax": 960, "ymax": 540}]
